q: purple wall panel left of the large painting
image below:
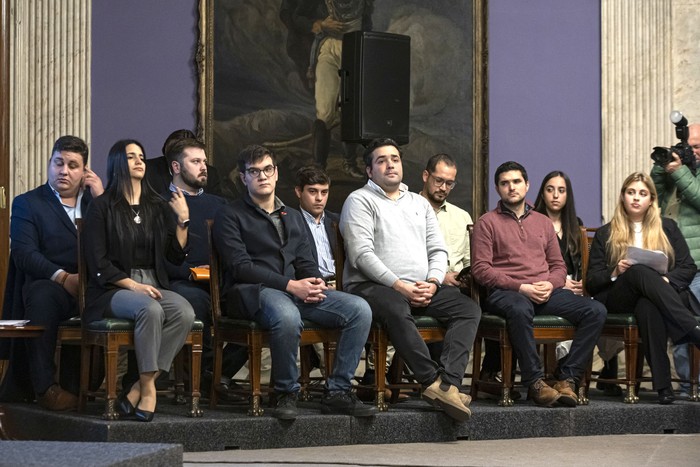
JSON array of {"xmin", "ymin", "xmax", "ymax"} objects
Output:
[{"xmin": 88, "ymin": 0, "xmax": 198, "ymax": 183}]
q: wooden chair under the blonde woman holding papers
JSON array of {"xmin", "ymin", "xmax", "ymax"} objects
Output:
[{"xmin": 581, "ymin": 227, "xmax": 700, "ymax": 404}]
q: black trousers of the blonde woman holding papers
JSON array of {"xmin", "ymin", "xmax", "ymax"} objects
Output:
[{"xmin": 596, "ymin": 265, "xmax": 698, "ymax": 391}]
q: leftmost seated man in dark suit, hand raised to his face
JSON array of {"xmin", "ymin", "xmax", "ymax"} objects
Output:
[{"xmin": 2, "ymin": 136, "xmax": 104, "ymax": 410}]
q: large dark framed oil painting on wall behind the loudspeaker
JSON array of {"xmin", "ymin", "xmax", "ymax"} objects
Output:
[{"xmin": 198, "ymin": 0, "xmax": 485, "ymax": 212}]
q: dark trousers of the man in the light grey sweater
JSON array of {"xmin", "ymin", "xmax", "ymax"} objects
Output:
[{"xmin": 350, "ymin": 282, "xmax": 481, "ymax": 387}]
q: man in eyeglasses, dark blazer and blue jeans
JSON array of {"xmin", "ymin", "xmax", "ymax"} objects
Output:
[{"xmin": 213, "ymin": 145, "xmax": 377, "ymax": 420}]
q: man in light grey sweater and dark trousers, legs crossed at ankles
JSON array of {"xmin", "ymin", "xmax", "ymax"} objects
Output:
[{"xmin": 340, "ymin": 139, "xmax": 481, "ymax": 421}]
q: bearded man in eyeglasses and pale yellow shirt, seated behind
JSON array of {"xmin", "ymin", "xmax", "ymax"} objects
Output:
[{"xmin": 420, "ymin": 154, "xmax": 472, "ymax": 287}]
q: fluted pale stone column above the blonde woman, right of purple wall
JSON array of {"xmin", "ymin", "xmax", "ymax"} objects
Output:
[{"xmin": 601, "ymin": 0, "xmax": 676, "ymax": 222}]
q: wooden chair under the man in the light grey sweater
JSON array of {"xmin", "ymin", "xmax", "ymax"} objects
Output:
[{"xmin": 333, "ymin": 222, "xmax": 446, "ymax": 412}]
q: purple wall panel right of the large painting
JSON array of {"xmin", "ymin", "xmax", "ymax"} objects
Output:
[{"xmin": 488, "ymin": 0, "xmax": 601, "ymax": 226}]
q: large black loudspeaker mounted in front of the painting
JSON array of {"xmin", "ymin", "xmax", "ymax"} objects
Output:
[{"xmin": 339, "ymin": 31, "xmax": 411, "ymax": 144}]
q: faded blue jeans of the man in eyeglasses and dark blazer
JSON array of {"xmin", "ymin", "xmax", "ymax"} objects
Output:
[{"xmin": 250, "ymin": 287, "xmax": 372, "ymax": 393}]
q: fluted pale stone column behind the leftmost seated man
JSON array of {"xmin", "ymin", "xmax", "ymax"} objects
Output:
[{"xmin": 8, "ymin": 0, "xmax": 92, "ymax": 200}]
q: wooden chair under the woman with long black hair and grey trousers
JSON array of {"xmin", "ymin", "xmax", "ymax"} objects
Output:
[{"xmin": 77, "ymin": 219, "xmax": 204, "ymax": 420}]
